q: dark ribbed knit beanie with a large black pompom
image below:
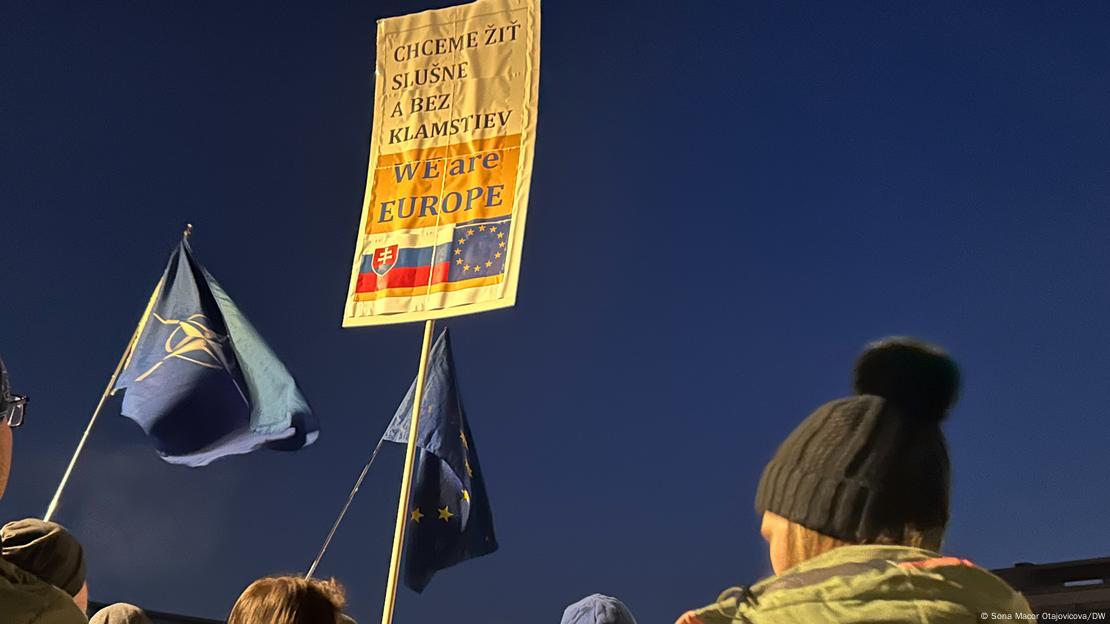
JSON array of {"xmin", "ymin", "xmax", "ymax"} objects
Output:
[{"xmin": 756, "ymin": 338, "xmax": 960, "ymax": 544}]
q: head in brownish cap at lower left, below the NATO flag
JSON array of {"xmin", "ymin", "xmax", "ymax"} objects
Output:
[{"xmin": 0, "ymin": 517, "xmax": 89, "ymax": 608}]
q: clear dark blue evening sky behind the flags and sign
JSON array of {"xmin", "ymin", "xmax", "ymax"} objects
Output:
[{"xmin": 0, "ymin": 0, "xmax": 1110, "ymax": 623}]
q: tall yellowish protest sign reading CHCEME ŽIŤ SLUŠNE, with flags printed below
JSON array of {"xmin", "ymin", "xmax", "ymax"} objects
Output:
[{"xmin": 343, "ymin": 0, "xmax": 539, "ymax": 326}]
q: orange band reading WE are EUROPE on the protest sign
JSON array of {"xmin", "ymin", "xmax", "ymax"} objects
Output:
[{"xmin": 363, "ymin": 134, "xmax": 521, "ymax": 234}]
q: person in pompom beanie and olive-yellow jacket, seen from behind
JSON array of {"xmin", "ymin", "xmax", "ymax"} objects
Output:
[{"xmin": 676, "ymin": 338, "xmax": 1036, "ymax": 624}]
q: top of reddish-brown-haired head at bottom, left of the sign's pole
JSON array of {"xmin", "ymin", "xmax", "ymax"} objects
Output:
[{"xmin": 228, "ymin": 576, "xmax": 346, "ymax": 624}]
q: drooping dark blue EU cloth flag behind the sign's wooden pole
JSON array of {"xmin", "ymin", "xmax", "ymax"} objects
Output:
[{"xmin": 385, "ymin": 330, "xmax": 497, "ymax": 592}]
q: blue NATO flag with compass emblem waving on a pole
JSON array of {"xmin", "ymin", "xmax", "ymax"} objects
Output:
[{"xmin": 115, "ymin": 240, "xmax": 320, "ymax": 466}]
